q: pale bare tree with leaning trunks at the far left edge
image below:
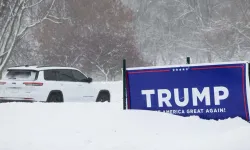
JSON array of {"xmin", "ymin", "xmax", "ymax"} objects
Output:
[{"xmin": 0, "ymin": 0, "xmax": 66, "ymax": 71}]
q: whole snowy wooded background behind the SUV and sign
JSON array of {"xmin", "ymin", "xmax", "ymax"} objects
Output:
[{"xmin": 0, "ymin": 0, "xmax": 250, "ymax": 80}]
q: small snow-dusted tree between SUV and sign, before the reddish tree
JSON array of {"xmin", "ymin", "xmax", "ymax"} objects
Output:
[{"xmin": 79, "ymin": 33, "xmax": 144, "ymax": 81}]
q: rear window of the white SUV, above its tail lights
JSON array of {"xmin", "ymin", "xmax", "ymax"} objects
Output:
[{"xmin": 5, "ymin": 70, "xmax": 38, "ymax": 81}]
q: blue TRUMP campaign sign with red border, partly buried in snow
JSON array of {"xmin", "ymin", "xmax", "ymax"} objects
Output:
[{"xmin": 126, "ymin": 62, "xmax": 250, "ymax": 121}]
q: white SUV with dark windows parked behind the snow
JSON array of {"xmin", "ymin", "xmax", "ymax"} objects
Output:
[{"xmin": 0, "ymin": 66, "xmax": 110, "ymax": 102}]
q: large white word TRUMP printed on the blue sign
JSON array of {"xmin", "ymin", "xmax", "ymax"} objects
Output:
[{"xmin": 141, "ymin": 86, "xmax": 229, "ymax": 107}]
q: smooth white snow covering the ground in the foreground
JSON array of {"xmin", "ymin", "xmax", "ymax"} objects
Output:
[{"xmin": 0, "ymin": 82, "xmax": 250, "ymax": 150}]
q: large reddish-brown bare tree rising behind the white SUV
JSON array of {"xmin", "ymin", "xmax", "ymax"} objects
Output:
[{"xmin": 35, "ymin": 0, "xmax": 145, "ymax": 80}]
